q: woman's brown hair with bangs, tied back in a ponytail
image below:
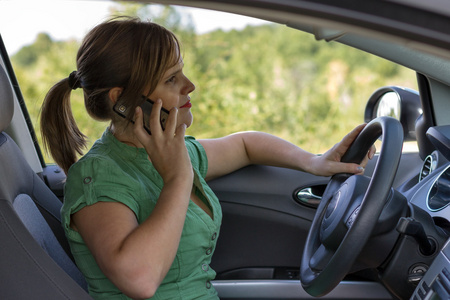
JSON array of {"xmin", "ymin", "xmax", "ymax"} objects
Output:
[{"xmin": 40, "ymin": 17, "xmax": 180, "ymax": 174}]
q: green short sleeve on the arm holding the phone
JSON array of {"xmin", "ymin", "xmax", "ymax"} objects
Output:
[{"xmin": 61, "ymin": 157, "xmax": 139, "ymax": 236}]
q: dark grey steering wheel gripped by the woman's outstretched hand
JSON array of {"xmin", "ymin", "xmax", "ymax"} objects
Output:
[{"xmin": 300, "ymin": 117, "xmax": 403, "ymax": 296}]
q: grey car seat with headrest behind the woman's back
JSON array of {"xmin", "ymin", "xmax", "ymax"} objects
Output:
[{"xmin": 0, "ymin": 62, "xmax": 92, "ymax": 299}]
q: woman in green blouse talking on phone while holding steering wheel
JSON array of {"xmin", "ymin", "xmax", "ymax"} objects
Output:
[{"xmin": 41, "ymin": 19, "xmax": 373, "ymax": 299}]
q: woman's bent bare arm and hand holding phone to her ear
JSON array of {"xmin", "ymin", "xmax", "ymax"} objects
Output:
[{"xmin": 72, "ymin": 102, "xmax": 194, "ymax": 298}]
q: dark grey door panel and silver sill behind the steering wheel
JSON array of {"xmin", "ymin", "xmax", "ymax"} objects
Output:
[{"xmin": 210, "ymin": 159, "xmax": 398, "ymax": 300}]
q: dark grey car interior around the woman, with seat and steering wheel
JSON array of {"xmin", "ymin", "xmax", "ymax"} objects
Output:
[{"xmin": 0, "ymin": 1, "xmax": 450, "ymax": 300}]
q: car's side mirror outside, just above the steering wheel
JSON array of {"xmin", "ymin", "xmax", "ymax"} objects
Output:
[{"xmin": 364, "ymin": 86, "xmax": 422, "ymax": 141}]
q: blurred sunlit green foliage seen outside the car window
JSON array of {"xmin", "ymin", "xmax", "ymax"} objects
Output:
[{"xmin": 12, "ymin": 4, "xmax": 416, "ymax": 161}]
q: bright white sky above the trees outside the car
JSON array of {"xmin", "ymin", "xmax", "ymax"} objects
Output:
[{"xmin": 0, "ymin": 0, "xmax": 264, "ymax": 55}]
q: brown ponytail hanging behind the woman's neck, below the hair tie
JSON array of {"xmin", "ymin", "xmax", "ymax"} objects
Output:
[{"xmin": 40, "ymin": 78, "xmax": 86, "ymax": 174}]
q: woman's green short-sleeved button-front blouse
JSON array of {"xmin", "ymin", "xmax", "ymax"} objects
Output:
[{"xmin": 61, "ymin": 130, "xmax": 222, "ymax": 300}]
